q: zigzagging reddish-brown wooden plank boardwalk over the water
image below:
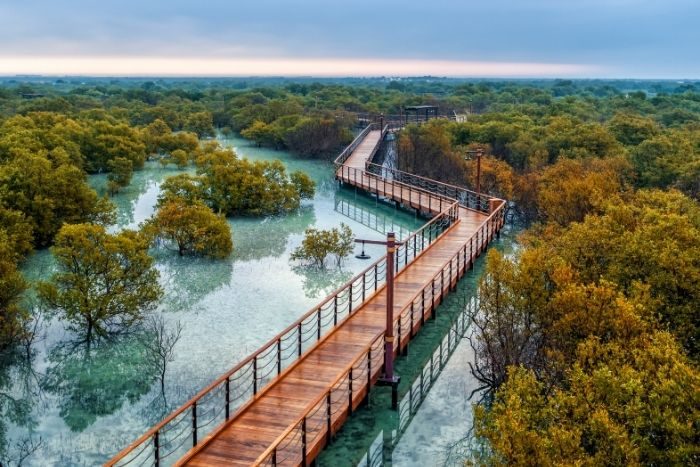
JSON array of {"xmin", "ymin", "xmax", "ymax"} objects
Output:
[{"xmin": 106, "ymin": 123, "xmax": 502, "ymax": 466}]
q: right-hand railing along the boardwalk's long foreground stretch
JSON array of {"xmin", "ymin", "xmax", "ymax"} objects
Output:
[{"xmin": 253, "ymin": 208, "xmax": 503, "ymax": 466}]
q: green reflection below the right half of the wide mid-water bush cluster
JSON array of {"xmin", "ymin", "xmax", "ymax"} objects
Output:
[{"xmin": 233, "ymin": 205, "xmax": 316, "ymax": 261}]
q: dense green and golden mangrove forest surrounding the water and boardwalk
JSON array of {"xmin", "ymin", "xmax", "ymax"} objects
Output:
[{"xmin": 0, "ymin": 78, "xmax": 700, "ymax": 465}]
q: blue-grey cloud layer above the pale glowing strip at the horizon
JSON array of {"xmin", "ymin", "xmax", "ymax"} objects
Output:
[{"xmin": 0, "ymin": 0, "xmax": 700, "ymax": 76}]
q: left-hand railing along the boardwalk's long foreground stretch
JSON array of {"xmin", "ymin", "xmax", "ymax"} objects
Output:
[{"xmin": 106, "ymin": 198, "xmax": 458, "ymax": 466}]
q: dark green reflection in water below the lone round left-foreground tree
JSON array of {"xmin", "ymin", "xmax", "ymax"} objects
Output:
[{"xmin": 42, "ymin": 336, "xmax": 154, "ymax": 431}]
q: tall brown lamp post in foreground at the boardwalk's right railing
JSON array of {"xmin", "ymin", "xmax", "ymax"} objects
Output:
[{"xmin": 355, "ymin": 232, "xmax": 403, "ymax": 410}]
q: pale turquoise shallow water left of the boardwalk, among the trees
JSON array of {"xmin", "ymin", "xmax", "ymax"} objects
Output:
[{"xmin": 0, "ymin": 138, "xmax": 424, "ymax": 465}]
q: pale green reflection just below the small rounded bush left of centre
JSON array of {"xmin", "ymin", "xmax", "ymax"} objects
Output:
[{"xmin": 154, "ymin": 250, "xmax": 233, "ymax": 311}]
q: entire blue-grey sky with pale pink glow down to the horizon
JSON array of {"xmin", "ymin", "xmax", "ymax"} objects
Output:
[{"xmin": 0, "ymin": 0, "xmax": 700, "ymax": 79}]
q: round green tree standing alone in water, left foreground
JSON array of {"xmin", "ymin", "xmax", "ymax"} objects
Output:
[{"xmin": 39, "ymin": 224, "xmax": 162, "ymax": 343}]
